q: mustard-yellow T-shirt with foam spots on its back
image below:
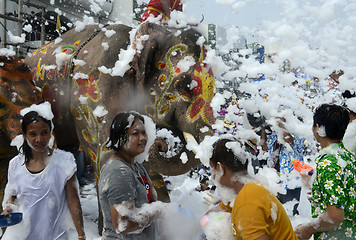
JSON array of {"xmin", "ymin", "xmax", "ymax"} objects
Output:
[{"xmin": 231, "ymin": 182, "xmax": 298, "ymax": 240}]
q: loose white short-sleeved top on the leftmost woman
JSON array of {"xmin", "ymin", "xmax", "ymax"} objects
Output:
[{"xmin": 2, "ymin": 149, "xmax": 77, "ymax": 240}]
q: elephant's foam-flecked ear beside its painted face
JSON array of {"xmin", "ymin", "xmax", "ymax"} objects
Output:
[{"xmin": 132, "ymin": 22, "xmax": 171, "ymax": 89}]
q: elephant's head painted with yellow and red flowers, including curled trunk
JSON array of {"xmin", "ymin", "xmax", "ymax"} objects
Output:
[{"xmin": 132, "ymin": 23, "xmax": 215, "ymax": 175}]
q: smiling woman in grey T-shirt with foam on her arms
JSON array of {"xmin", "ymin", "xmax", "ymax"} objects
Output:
[{"xmin": 99, "ymin": 112, "xmax": 168, "ymax": 240}]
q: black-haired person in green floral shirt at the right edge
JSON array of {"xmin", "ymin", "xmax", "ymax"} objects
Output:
[{"xmin": 295, "ymin": 104, "xmax": 356, "ymax": 240}]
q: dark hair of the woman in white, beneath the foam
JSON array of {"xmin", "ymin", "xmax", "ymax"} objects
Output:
[{"xmin": 21, "ymin": 111, "xmax": 52, "ymax": 164}]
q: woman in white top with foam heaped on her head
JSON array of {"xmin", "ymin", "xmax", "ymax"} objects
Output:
[{"xmin": 2, "ymin": 102, "xmax": 85, "ymax": 240}]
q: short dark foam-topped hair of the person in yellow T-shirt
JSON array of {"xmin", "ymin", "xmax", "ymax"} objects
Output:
[{"xmin": 210, "ymin": 139, "xmax": 248, "ymax": 173}]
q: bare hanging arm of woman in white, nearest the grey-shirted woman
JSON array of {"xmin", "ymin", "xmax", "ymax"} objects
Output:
[{"xmin": 66, "ymin": 173, "xmax": 85, "ymax": 239}]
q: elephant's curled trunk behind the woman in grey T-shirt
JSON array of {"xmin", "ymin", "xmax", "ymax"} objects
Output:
[{"xmin": 144, "ymin": 138, "xmax": 201, "ymax": 176}]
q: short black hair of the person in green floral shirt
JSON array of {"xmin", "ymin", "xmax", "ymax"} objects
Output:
[{"xmin": 313, "ymin": 104, "xmax": 350, "ymax": 140}]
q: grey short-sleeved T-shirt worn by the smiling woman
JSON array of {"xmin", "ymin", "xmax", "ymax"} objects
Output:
[{"xmin": 99, "ymin": 159, "xmax": 156, "ymax": 240}]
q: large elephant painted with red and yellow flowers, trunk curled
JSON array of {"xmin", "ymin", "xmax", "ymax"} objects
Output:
[{"xmin": 25, "ymin": 23, "xmax": 215, "ymax": 184}]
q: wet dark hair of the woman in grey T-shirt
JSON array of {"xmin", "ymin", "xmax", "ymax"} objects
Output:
[{"xmin": 106, "ymin": 112, "xmax": 145, "ymax": 152}]
